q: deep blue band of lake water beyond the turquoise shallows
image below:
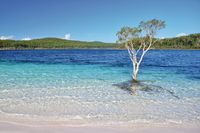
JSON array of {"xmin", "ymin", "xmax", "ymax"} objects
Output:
[{"xmin": 0, "ymin": 49, "xmax": 200, "ymax": 80}]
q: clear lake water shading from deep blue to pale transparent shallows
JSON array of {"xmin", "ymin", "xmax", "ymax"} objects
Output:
[{"xmin": 0, "ymin": 50, "xmax": 200, "ymax": 125}]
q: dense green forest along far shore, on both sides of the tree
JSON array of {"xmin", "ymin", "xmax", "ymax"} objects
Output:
[{"xmin": 0, "ymin": 33, "xmax": 200, "ymax": 49}]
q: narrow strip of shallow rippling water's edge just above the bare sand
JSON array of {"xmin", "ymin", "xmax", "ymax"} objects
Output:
[{"xmin": 0, "ymin": 114, "xmax": 200, "ymax": 129}]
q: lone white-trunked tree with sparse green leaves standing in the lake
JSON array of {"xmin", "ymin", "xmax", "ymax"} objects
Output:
[{"xmin": 116, "ymin": 19, "xmax": 165, "ymax": 82}]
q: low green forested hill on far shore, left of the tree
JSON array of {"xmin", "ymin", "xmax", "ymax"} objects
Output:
[{"xmin": 0, "ymin": 38, "xmax": 116, "ymax": 49}]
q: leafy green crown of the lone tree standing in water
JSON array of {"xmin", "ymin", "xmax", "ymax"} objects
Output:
[{"xmin": 116, "ymin": 19, "xmax": 165, "ymax": 49}]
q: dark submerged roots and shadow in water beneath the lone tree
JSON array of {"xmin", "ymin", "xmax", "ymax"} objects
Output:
[{"xmin": 114, "ymin": 80, "xmax": 179, "ymax": 99}]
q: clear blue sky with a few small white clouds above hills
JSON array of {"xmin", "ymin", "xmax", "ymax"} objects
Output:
[{"xmin": 0, "ymin": 0, "xmax": 200, "ymax": 42}]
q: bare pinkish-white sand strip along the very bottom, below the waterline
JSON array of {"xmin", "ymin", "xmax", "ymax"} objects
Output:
[{"xmin": 0, "ymin": 122, "xmax": 200, "ymax": 133}]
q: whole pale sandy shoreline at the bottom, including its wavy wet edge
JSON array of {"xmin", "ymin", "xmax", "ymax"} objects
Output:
[{"xmin": 0, "ymin": 115, "xmax": 200, "ymax": 133}]
